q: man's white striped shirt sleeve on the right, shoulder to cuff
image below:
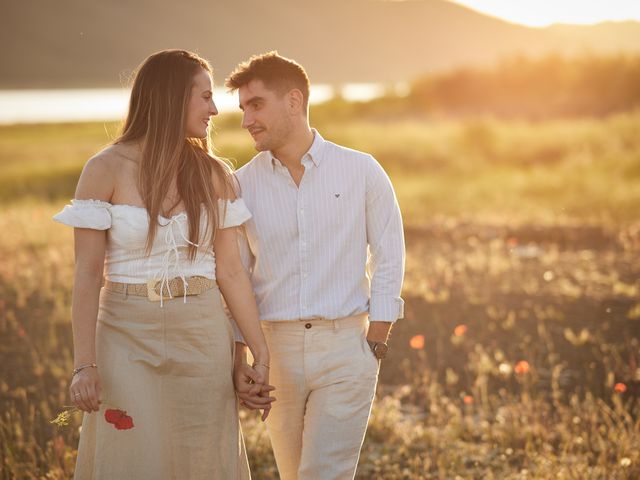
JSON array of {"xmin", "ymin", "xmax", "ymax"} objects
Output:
[{"xmin": 366, "ymin": 157, "xmax": 405, "ymax": 322}]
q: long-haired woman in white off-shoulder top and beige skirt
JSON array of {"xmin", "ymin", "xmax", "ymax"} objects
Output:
[{"xmin": 54, "ymin": 50, "xmax": 269, "ymax": 480}]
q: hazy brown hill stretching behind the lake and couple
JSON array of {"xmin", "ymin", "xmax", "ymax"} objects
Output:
[{"xmin": 0, "ymin": 0, "xmax": 640, "ymax": 88}]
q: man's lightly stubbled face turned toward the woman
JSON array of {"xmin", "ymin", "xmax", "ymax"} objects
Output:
[{"xmin": 238, "ymin": 80, "xmax": 293, "ymax": 152}]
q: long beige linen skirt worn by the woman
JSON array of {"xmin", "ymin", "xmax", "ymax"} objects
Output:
[{"xmin": 75, "ymin": 288, "xmax": 250, "ymax": 480}]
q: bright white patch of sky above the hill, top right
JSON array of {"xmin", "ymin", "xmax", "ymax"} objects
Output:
[{"xmin": 450, "ymin": 0, "xmax": 640, "ymax": 27}]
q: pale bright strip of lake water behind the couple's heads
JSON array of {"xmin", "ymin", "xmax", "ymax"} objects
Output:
[{"xmin": 0, "ymin": 83, "xmax": 385, "ymax": 125}]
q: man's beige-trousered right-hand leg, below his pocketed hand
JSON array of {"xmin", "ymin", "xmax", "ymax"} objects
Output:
[{"xmin": 296, "ymin": 321, "xmax": 378, "ymax": 480}]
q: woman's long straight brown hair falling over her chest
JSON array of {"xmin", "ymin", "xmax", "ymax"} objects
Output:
[{"xmin": 114, "ymin": 50, "xmax": 234, "ymax": 260}]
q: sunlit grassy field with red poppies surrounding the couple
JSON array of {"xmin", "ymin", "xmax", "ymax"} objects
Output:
[{"xmin": 0, "ymin": 112, "xmax": 640, "ymax": 480}]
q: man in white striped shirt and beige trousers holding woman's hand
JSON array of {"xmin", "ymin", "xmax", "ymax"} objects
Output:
[{"xmin": 226, "ymin": 52, "xmax": 404, "ymax": 480}]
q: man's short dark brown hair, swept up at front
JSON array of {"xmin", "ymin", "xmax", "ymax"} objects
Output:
[{"xmin": 225, "ymin": 51, "xmax": 309, "ymax": 109}]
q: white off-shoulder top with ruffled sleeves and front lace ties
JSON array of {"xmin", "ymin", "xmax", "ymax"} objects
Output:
[{"xmin": 53, "ymin": 198, "xmax": 251, "ymax": 300}]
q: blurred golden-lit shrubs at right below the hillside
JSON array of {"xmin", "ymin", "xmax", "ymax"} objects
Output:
[{"xmin": 405, "ymin": 54, "xmax": 640, "ymax": 119}]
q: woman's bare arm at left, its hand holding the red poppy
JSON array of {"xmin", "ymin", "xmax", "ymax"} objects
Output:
[{"xmin": 69, "ymin": 155, "xmax": 113, "ymax": 412}]
